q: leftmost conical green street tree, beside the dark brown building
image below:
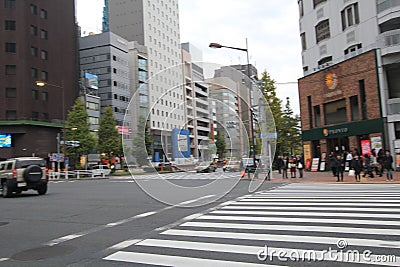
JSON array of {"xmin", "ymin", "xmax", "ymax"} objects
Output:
[{"xmin": 64, "ymin": 98, "xmax": 96, "ymax": 168}]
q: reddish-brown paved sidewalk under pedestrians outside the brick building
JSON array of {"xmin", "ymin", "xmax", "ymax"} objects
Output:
[{"xmin": 270, "ymin": 171, "xmax": 400, "ymax": 184}]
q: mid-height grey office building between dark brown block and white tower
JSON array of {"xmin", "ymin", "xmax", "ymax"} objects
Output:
[{"xmin": 79, "ymin": 32, "xmax": 131, "ymax": 126}]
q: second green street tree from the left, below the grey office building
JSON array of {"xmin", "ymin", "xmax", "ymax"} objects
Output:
[{"xmin": 98, "ymin": 107, "xmax": 122, "ymax": 157}]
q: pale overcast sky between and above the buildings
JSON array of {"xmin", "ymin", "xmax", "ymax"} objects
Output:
[{"xmin": 77, "ymin": 0, "xmax": 302, "ymax": 113}]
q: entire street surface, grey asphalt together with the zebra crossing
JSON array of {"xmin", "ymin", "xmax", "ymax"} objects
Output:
[{"xmin": 0, "ymin": 173, "xmax": 400, "ymax": 266}]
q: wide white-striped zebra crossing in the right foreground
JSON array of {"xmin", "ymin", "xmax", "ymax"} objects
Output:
[{"xmin": 103, "ymin": 184, "xmax": 400, "ymax": 267}]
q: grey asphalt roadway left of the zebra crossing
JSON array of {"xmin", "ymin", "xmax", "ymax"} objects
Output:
[{"xmin": 0, "ymin": 173, "xmax": 279, "ymax": 266}]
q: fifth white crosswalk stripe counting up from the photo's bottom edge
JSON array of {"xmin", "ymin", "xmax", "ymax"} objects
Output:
[{"xmin": 197, "ymin": 215, "xmax": 400, "ymax": 226}]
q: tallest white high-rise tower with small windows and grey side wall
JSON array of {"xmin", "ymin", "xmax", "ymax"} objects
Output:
[{"xmin": 108, "ymin": 0, "xmax": 185, "ymax": 160}]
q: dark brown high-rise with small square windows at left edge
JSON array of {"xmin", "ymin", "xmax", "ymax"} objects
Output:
[{"xmin": 0, "ymin": 0, "xmax": 79, "ymax": 159}]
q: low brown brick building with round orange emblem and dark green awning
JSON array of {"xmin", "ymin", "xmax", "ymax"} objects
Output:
[{"xmin": 299, "ymin": 50, "xmax": 385, "ymax": 170}]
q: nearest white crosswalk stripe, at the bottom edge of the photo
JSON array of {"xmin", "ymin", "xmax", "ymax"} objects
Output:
[{"xmin": 104, "ymin": 251, "xmax": 277, "ymax": 267}]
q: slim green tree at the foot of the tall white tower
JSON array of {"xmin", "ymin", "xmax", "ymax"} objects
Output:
[{"xmin": 132, "ymin": 116, "xmax": 152, "ymax": 165}]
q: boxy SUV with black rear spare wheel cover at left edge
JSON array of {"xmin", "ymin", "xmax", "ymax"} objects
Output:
[{"xmin": 0, "ymin": 157, "xmax": 48, "ymax": 197}]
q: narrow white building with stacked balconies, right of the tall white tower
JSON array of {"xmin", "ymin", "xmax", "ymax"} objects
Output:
[{"xmin": 182, "ymin": 43, "xmax": 210, "ymax": 158}]
